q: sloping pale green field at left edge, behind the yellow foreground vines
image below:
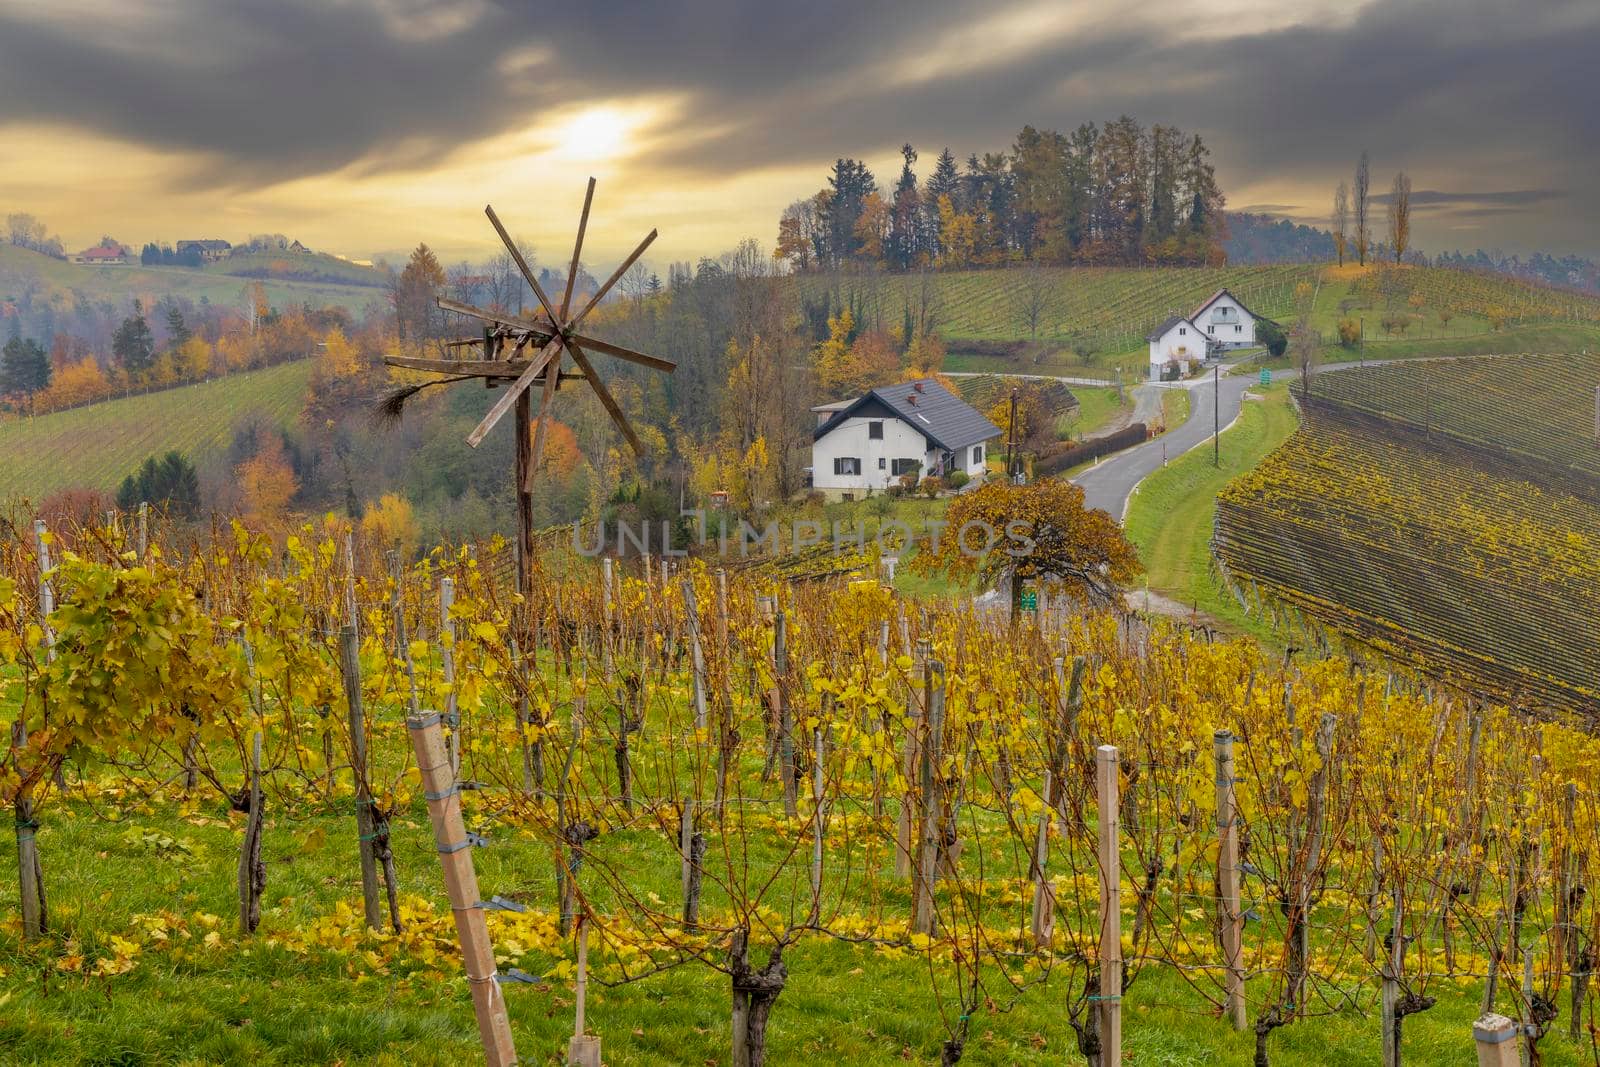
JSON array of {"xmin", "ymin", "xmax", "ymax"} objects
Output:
[{"xmin": 0, "ymin": 360, "xmax": 310, "ymax": 501}]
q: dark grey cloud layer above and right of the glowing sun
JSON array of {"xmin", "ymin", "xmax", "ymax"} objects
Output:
[{"xmin": 0, "ymin": 0, "xmax": 1600, "ymax": 251}]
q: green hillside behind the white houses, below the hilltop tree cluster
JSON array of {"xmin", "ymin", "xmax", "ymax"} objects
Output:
[{"xmin": 798, "ymin": 264, "xmax": 1600, "ymax": 373}]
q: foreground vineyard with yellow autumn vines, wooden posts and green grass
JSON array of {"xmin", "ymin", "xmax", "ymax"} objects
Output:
[{"xmin": 0, "ymin": 520, "xmax": 1600, "ymax": 1064}]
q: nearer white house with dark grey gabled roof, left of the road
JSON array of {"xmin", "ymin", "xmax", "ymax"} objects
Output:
[{"xmin": 811, "ymin": 379, "xmax": 1000, "ymax": 501}]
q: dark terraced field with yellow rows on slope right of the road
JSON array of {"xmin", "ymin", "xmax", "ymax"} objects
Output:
[{"xmin": 1213, "ymin": 357, "xmax": 1600, "ymax": 710}]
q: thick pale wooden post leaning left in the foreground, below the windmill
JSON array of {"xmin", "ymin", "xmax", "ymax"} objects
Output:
[{"xmin": 406, "ymin": 710, "xmax": 526, "ymax": 1067}]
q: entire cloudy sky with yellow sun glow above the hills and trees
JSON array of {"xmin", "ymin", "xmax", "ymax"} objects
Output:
[{"xmin": 0, "ymin": 0, "xmax": 1600, "ymax": 269}]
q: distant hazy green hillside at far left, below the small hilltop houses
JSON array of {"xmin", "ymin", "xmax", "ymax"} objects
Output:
[{"xmin": 0, "ymin": 243, "xmax": 386, "ymax": 319}]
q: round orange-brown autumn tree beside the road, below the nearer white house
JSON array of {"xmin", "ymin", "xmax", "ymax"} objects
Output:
[{"xmin": 912, "ymin": 478, "xmax": 1142, "ymax": 617}]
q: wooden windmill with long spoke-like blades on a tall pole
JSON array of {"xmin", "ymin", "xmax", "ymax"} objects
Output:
[{"xmin": 384, "ymin": 178, "xmax": 677, "ymax": 585}]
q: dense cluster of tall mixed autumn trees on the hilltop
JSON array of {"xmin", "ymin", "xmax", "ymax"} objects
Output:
[{"xmin": 776, "ymin": 115, "xmax": 1226, "ymax": 270}]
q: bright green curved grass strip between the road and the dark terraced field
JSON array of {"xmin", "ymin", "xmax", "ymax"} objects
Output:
[{"xmin": 1126, "ymin": 384, "xmax": 1298, "ymax": 645}]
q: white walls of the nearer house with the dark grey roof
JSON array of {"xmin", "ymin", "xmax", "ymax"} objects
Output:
[{"xmin": 811, "ymin": 414, "xmax": 989, "ymax": 496}]
